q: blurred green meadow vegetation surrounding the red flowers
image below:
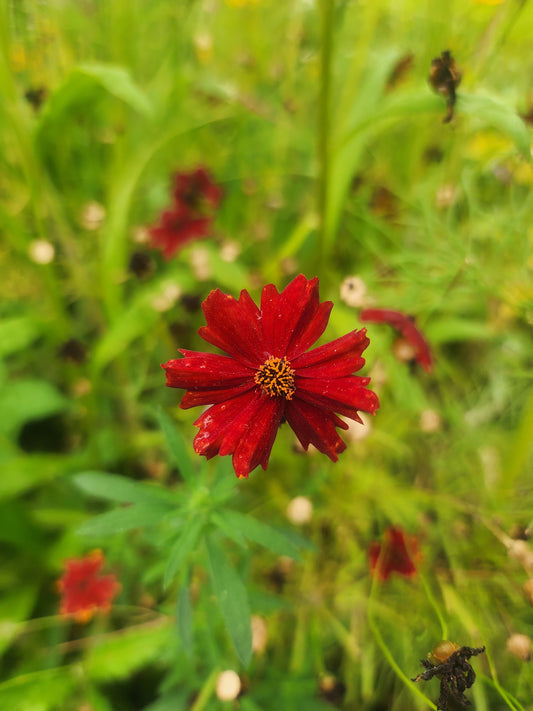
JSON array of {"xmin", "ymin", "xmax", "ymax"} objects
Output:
[{"xmin": 0, "ymin": 0, "xmax": 533, "ymax": 711}]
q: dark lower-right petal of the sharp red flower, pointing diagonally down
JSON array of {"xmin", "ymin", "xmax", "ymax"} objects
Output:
[{"xmin": 285, "ymin": 400, "xmax": 348, "ymax": 462}]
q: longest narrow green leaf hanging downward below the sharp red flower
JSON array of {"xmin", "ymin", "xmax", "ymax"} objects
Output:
[{"xmin": 207, "ymin": 539, "xmax": 252, "ymax": 666}]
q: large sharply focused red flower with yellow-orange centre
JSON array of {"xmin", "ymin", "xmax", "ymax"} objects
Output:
[{"xmin": 162, "ymin": 274, "xmax": 379, "ymax": 477}]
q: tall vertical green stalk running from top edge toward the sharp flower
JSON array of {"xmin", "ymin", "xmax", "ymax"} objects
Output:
[{"xmin": 315, "ymin": 0, "xmax": 335, "ymax": 268}]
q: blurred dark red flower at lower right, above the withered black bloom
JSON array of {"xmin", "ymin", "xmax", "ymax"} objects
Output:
[{"xmin": 368, "ymin": 526, "xmax": 421, "ymax": 581}]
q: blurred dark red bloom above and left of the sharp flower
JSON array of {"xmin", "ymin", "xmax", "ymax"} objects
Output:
[{"xmin": 148, "ymin": 167, "xmax": 222, "ymax": 259}]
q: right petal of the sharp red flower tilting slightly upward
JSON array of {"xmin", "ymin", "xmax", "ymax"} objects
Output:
[{"xmin": 291, "ymin": 328, "xmax": 370, "ymax": 378}]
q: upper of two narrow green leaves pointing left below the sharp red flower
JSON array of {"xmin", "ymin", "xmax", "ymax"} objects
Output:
[{"xmin": 72, "ymin": 471, "xmax": 174, "ymax": 508}]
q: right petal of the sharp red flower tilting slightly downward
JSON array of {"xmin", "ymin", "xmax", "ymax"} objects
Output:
[{"xmin": 294, "ymin": 374, "xmax": 379, "ymax": 419}]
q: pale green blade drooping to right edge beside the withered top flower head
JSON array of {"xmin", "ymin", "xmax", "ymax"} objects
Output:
[{"xmin": 457, "ymin": 92, "xmax": 531, "ymax": 160}]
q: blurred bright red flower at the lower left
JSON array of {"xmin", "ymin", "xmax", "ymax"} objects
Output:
[{"xmin": 57, "ymin": 550, "xmax": 120, "ymax": 622}]
